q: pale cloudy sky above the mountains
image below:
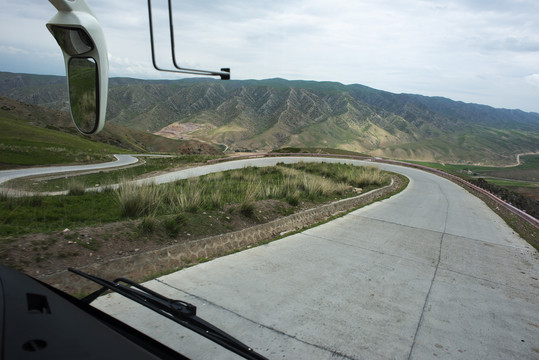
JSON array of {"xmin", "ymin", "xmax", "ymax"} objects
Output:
[{"xmin": 0, "ymin": 0, "xmax": 539, "ymax": 112}]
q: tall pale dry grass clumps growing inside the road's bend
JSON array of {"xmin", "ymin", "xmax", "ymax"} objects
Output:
[{"xmin": 116, "ymin": 163, "xmax": 389, "ymax": 217}]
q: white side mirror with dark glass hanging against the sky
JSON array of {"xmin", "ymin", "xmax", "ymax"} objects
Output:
[{"xmin": 47, "ymin": 0, "xmax": 109, "ymax": 135}]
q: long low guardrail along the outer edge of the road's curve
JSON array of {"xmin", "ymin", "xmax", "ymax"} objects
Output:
[{"xmin": 208, "ymin": 153, "xmax": 539, "ymax": 229}]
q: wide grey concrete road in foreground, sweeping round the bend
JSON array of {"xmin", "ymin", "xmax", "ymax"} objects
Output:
[{"xmin": 94, "ymin": 158, "xmax": 539, "ymax": 359}]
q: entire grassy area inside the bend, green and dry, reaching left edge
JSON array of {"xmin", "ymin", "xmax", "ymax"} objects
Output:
[{"xmin": 0, "ymin": 163, "xmax": 390, "ymax": 236}]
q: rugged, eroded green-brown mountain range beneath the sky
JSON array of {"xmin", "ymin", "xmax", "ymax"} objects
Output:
[{"xmin": 0, "ymin": 72, "xmax": 539, "ymax": 164}]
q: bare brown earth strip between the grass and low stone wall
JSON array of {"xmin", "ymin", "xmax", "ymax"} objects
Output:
[{"xmin": 0, "ymin": 200, "xmax": 302, "ymax": 277}]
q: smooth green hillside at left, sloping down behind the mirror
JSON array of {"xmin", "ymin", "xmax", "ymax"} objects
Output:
[{"xmin": 0, "ymin": 97, "xmax": 220, "ymax": 169}]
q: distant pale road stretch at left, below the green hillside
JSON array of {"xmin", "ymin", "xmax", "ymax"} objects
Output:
[{"xmin": 0, "ymin": 155, "xmax": 138, "ymax": 185}]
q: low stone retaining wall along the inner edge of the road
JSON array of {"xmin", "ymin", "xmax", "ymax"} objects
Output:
[{"xmin": 40, "ymin": 176, "xmax": 403, "ymax": 294}]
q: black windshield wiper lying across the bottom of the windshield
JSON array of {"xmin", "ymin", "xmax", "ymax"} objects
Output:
[{"xmin": 68, "ymin": 268, "xmax": 266, "ymax": 360}]
